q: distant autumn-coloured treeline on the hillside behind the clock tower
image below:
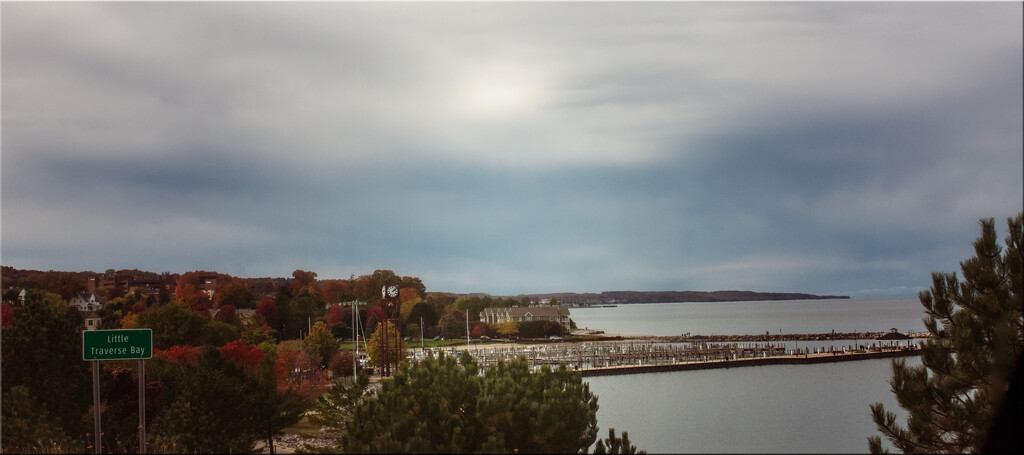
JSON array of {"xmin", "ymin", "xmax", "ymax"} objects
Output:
[{"xmin": 0, "ymin": 266, "xmax": 568, "ymax": 341}]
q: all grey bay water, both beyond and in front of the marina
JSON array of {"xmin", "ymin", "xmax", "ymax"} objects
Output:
[{"xmin": 570, "ymin": 297, "xmax": 925, "ymax": 453}]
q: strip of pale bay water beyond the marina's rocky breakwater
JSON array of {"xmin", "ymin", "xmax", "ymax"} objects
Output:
[{"xmin": 569, "ymin": 297, "xmax": 925, "ymax": 336}]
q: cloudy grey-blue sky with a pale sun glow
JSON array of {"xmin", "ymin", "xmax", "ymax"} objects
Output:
[{"xmin": 0, "ymin": 2, "xmax": 1024, "ymax": 297}]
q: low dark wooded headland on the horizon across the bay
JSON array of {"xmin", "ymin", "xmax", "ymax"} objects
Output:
[{"xmin": 526, "ymin": 291, "xmax": 850, "ymax": 304}]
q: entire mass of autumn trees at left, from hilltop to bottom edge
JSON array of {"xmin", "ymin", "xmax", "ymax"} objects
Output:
[{"xmin": 0, "ymin": 267, "xmax": 564, "ymax": 453}]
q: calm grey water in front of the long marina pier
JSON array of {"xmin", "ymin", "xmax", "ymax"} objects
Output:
[{"xmin": 587, "ymin": 358, "xmax": 921, "ymax": 453}]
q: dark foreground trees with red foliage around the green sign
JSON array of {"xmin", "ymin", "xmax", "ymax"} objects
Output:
[{"xmin": 0, "ymin": 290, "xmax": 325, "ymax": 453}]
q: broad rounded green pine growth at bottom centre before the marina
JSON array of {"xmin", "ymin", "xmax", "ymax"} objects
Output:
[{"xmin": 344, "ymin": 354, "xmax": 610, "ymax": 453}]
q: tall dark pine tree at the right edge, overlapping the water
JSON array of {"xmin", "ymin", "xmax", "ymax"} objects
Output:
[{"xmin": 868, "ymin": 212, "xmax": 1024, "ymax": 453}]
